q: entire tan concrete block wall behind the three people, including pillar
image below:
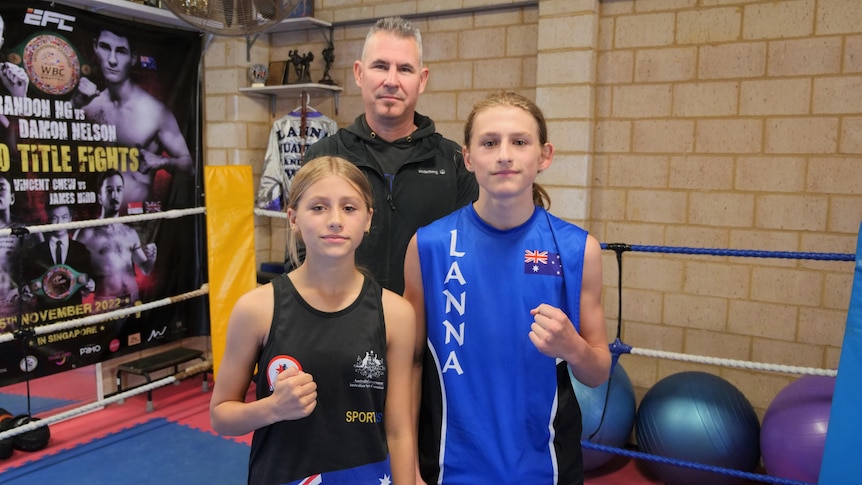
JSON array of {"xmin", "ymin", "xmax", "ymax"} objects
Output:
[{"xmin": 205, "ymin": 0, "xmax": 862, "ymax": 414}]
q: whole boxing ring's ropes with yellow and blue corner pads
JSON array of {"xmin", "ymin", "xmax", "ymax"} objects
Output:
[{"xmin": 0, "ymin": 167, "xmax": 862, "ymax": 485}]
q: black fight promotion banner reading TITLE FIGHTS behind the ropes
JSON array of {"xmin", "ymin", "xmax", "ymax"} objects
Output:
[{"xmin": 0, "ymin": 0, "xmax": 207, "ymax": 386}]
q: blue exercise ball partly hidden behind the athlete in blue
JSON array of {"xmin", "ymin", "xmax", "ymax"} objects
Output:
[{"xmin": 569, "ymin": 362, "xmax": 636, "ymax": 471}]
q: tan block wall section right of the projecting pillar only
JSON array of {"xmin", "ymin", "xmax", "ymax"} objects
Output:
[{"xmin": 589, "ymin": 0, "xmax": 862, "ymax": 412}]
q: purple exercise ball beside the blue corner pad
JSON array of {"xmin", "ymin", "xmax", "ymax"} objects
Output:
[{"xmin": 760, "ymin": 376, "xmax": 835, "ymax": 483}]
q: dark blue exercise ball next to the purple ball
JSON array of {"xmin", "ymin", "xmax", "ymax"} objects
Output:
[{"xmin": 635, "ymin": 372, "xmax": 760, "ymax": 485}]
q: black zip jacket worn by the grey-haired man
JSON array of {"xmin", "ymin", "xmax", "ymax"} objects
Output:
[{"xmin": 303, "ymin": 113, "xmax": 479, "ymax": 295}]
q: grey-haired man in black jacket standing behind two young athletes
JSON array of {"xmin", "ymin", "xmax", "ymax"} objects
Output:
[{"xmin": 303, "ymin": 17, "xmax": 479, "ymax": 294}]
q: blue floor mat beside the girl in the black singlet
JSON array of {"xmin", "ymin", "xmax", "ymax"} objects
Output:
[{"xmin": 0, "ymin": 418, "xmax": 249, "ymax": 485}]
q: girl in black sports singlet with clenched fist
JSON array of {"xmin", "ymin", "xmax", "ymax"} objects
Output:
[{"xmin": 210, "ymin": 157, "xmax": 416, "ymax": 485}]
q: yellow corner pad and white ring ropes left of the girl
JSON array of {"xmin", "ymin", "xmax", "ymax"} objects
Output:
[{"xmin": 0, "ymin": 167, "xmax": 256, "ymax": 454}]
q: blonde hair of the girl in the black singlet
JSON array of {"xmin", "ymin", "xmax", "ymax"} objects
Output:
[{"xmin": 287, "ymin": 156, "xmax": 373, "ymax": 267}]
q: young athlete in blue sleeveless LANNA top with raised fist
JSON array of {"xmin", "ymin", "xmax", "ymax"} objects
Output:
[{"xmin": 404, "ymin": 93, "xmax": 611, "ymax": 485}]
